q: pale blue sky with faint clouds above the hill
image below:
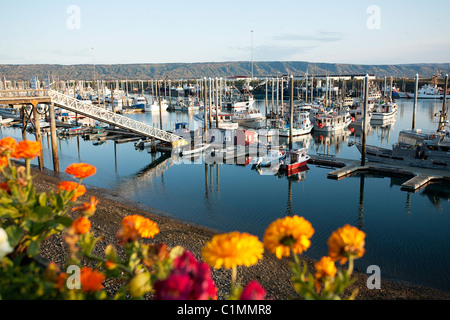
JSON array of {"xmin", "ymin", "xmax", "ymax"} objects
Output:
[{"xmin": 0, "ymin": 0, "xmax": 450, "ymax": 64}]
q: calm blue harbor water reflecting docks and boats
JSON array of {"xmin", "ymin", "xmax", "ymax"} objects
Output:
[{"xmin": 0, "ymin": 100, "xmax": 450, "ymax": 292}]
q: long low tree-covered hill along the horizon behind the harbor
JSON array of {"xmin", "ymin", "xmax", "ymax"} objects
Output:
[{"xmin": 0, "ymin": 61, "xmax": 450, "ymax": 81}]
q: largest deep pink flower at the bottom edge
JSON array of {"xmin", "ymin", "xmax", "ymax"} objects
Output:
[{"xmin": 154, "ymin": 251, "xmax": 217, "ymax": 300}]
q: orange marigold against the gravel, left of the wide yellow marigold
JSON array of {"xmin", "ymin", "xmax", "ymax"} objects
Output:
[{"xmin": 117, "ymin": 215, "xmax": 159, "ymax": 242}]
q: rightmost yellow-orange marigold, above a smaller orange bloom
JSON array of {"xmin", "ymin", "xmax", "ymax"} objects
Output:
[{"xmin": 328, "ymin": 224, "xmax": 366, "ymax": 264}]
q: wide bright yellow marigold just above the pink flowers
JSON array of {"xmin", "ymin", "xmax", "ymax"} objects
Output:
[{"xmin": 202, "ymin": 231, "xmax": 264, "ymax": 269}]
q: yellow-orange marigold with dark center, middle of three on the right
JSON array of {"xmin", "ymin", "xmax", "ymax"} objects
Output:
[{"xmin": 263, "ymin": 215, "xmax": 314, "ymax": 259}]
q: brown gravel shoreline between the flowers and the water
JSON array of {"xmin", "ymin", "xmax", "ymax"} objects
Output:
[{"xmin": 32, "ymin": 168, "xmax": 450, "ymax": 300}]
